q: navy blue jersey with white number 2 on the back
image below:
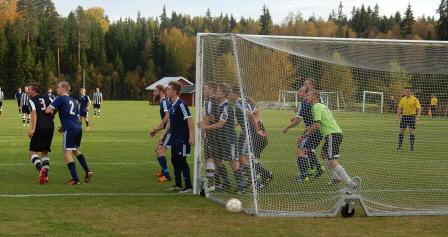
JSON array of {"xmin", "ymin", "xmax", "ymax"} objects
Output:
[{"xmin": 50, "ymin": 95, "xmax": 81, "ymax": 131}]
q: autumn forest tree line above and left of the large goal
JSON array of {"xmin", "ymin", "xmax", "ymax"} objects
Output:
[{"xmin": 0, "ymin": 0, "xmax": 448, "ymax": 99}]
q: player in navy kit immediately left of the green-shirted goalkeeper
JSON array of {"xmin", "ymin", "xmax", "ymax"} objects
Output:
[{"xmin": 283, "ymin": 86, "xmax": 322, "ymax": 183}]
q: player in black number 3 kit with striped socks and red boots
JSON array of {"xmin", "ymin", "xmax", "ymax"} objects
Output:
[{"xmin": 28, "ymin": 84, "xmax": 54, "ymax": 184}]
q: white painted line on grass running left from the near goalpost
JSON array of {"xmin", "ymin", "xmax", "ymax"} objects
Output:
[{"xmin": 0, "ymin": 193, "xmax": 193, "ymax": 198}]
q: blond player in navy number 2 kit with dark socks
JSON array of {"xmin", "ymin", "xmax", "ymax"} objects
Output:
[{"xmin": 45, "ymin": 81, "xmax": 93, "ymax": 186}]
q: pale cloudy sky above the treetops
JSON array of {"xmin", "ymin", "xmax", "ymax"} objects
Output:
[{"xmin": 54, "ymin": 0, "xmax": 441, "ymax": 23}]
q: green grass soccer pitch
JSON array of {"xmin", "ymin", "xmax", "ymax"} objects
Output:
[{"xmin": 0, "ymin": 101, "xmax": 448, "ymax": 236}]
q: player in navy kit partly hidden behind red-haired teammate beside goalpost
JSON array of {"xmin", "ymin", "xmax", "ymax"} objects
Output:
[{"xmin": 150, "ymin": 85, "xmax": 171, "ymax": 182}]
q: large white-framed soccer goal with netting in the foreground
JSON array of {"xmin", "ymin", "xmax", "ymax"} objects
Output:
[{"xmin": 194, "ymin": 33, "xmax": 448, "ymax": 217}]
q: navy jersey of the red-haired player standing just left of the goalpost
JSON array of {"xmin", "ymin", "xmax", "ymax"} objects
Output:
[{"xmin": 170, "ymin": 98, "xmax": 191, "ymax": 144}]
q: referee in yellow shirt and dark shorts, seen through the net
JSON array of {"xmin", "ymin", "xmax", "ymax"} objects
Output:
[{"xmin": 397, "ymin": 87, "xmax": 422, "ymax": 151}]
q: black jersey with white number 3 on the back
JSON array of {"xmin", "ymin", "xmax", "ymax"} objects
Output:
[{"xmin": 29, "ymin": 95, "xmax": 54, "ymax": 130}]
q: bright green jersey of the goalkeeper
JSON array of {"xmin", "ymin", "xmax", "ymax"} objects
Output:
[{"xmin": 313, "ymin": 103, "xmax": 342, "ymax": 136}]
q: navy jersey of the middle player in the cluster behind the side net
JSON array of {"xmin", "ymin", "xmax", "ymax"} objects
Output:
[{"xmin": 218, "ymin": 100, "xmax": 236, "ymax": 144}]
